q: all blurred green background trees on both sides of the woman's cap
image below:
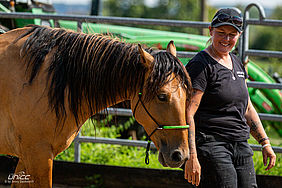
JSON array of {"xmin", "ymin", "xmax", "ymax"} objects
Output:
[{"xmin": 103, "ymin": 0, "xmax": 282, "ymax": 75}]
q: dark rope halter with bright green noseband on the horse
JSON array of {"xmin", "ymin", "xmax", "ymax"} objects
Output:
[{"xmin": 133, "ymin": 84, "xmax": 189, "ymax": 165}]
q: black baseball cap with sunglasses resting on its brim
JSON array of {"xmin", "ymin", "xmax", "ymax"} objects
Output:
[{"xmin": 211, "ymin": 8, "xmax": 243, "ymax": 32}]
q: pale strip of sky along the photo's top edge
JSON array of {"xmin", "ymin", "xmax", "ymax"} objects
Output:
[{"xmin": 52, "ymin": 0, "xmax": 282, "ymax": 8}]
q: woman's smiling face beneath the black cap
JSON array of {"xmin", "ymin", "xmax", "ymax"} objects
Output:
[{"xmin": 210, "ymin": 25, "xmax": 241, "ymax": 54}]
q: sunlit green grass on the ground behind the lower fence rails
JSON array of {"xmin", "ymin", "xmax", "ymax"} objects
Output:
[{"xmin": 56, "ymin": 117, "xmax": 282, "ymax": 176}]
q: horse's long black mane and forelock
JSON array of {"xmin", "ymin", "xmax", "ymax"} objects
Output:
[{"xmin": 15, "ymin": 25, "xmax": 191, "ymax": 125}]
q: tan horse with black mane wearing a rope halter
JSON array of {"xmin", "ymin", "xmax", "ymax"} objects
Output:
[{"xmin": 0, "ymin": 25, "xmax": 192, "ymax": 188}]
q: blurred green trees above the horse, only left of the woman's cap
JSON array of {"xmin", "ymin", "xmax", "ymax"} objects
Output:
[{"xmin": 103, "ymin": 0, "xmax": 215, "ymax": 34}]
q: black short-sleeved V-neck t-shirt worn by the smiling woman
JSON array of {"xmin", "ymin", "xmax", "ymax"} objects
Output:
[{"xmin": 186, "ymin": 51, "xmax": 250, "ymax": 141}]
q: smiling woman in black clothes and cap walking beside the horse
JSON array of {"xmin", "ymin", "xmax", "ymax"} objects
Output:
[{"xmin": 185, "ymin": 9, "xmax": 276, "ymax": 188}]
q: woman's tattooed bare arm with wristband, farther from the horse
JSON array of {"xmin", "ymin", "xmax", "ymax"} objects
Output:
[{"xmin": 245, "ymin": 98, "xmax": 276, "ymax": 170}]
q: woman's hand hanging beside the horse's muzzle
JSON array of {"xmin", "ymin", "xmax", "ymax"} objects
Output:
[{"xmin": 184, "ymin": 155, "xmax": 201, "ymax": 186}]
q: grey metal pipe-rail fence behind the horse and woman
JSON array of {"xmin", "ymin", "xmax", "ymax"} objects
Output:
[{"xmin": 0, "ymin": 3, "xmax": 282, "ymax": 162}]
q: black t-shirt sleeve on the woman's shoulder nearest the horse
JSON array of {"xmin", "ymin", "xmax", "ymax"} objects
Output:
[{"xmin": 186, "ymin": 59, "xmax": 207, "ymax": 92}]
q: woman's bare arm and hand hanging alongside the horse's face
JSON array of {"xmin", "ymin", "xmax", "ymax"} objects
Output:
[{"xmin": 184, "ymin": 89, "xmax": 204, "ymax": 186}]
